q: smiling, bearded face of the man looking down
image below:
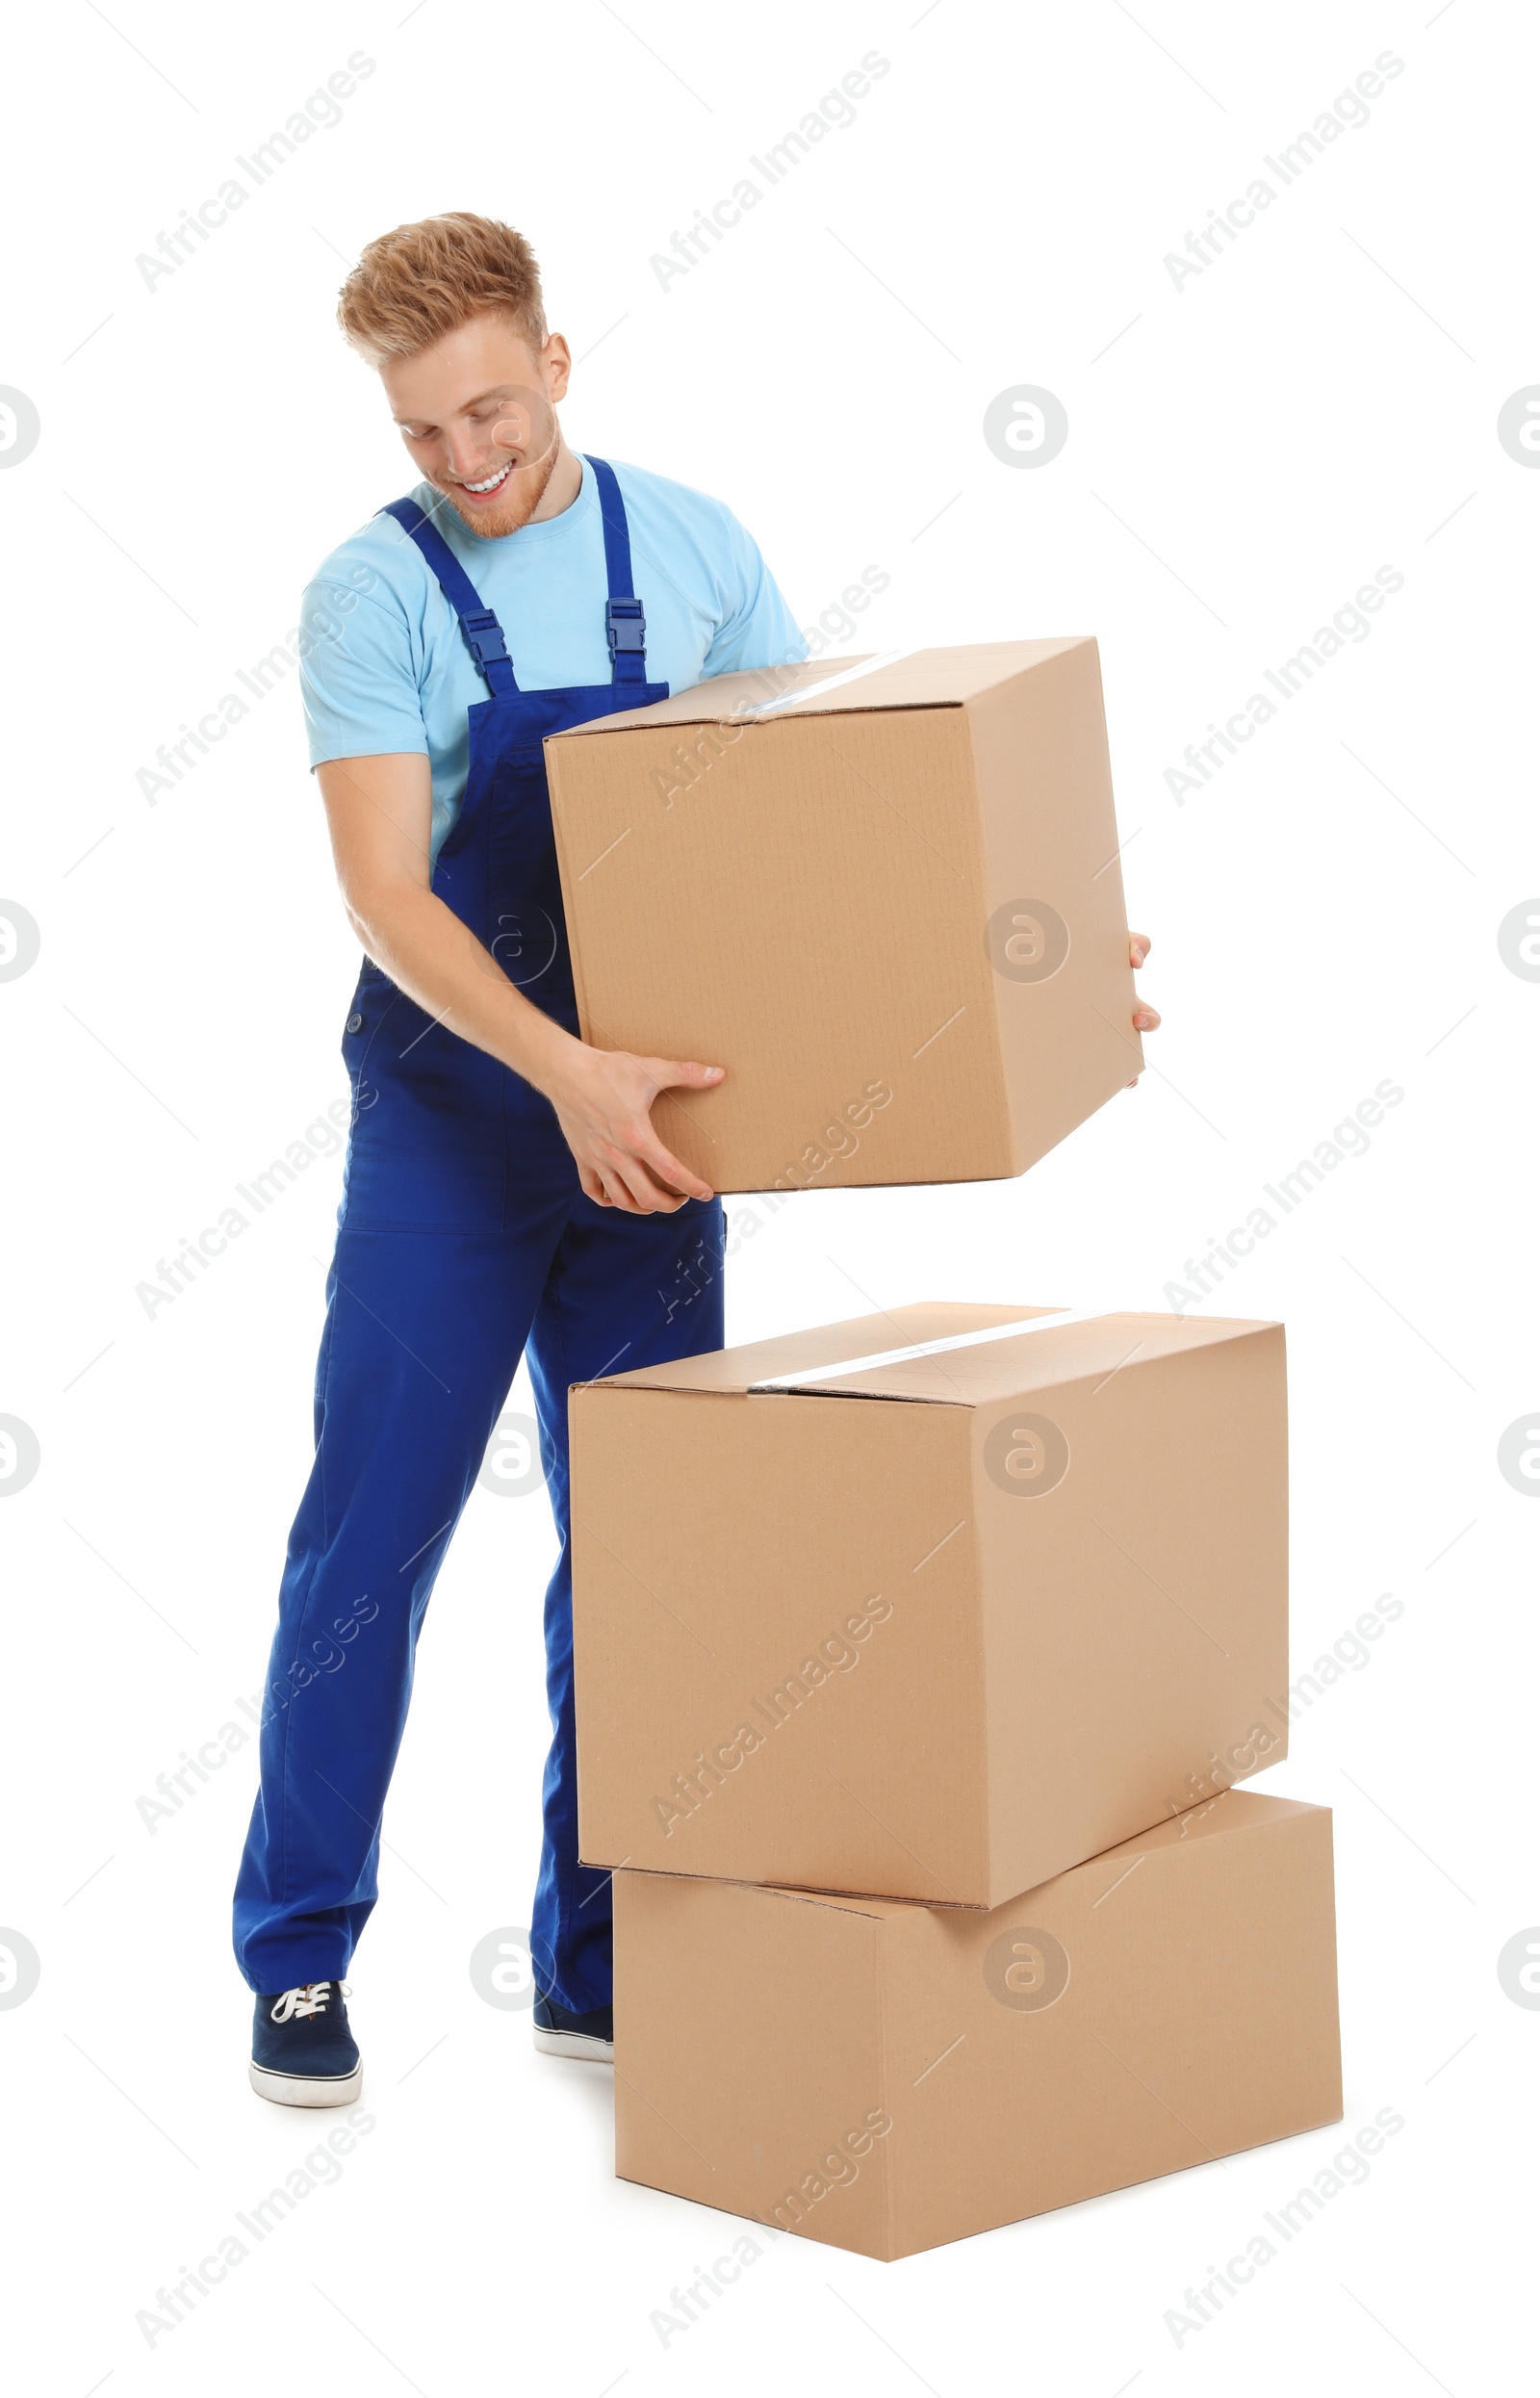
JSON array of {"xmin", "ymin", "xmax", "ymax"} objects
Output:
[{"xmin": 379, "ymin": 317, "xmax": 571, "ymax": 534}]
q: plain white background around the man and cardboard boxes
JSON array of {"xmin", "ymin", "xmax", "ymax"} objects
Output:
[{"xmin": 0, "ymin": 0, "xmax": 1540, "ymax": 2398}]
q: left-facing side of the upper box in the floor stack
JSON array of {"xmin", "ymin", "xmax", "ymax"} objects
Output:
[{"xmin": 574, "ymin": 1388, "xmax": 988, "ymax": 1904}]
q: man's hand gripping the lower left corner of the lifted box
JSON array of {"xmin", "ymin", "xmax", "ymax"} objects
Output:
[{"xmin": 542, "ymin": 1041, "xmax": 722, "ymax": 1216}]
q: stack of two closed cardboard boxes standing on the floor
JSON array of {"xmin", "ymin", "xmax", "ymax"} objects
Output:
[{"xmin": 571, "ymin": 1304, "xmax": 1341, "ymax": 2256}]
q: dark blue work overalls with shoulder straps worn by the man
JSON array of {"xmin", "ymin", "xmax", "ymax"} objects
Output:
[{"xmin": 235, "ymin": 458, "xmax": 722, "ymax": 2014}]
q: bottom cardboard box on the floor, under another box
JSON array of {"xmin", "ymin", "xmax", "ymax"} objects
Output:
[{"xmin": 614, "ymin": 1792, "xmax": 1341, "ymax": 2259}]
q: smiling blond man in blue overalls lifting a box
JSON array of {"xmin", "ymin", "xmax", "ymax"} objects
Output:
[{"xmin": 235, "ymin": 214, "xmax": 1154, "ymax": 2105}]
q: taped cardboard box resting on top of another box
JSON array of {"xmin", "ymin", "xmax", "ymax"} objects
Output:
[{"xmin": 569, "ymin": 1304, "xmax": 1288, "ymax": 1906}]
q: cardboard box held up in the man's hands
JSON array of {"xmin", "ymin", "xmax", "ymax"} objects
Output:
[{"xmin": 545, "ymin": 638, "xmax": 1142, "ymax": 1192}]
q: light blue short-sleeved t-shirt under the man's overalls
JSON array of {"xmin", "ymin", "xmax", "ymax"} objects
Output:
[{"xmin": 300, "ymin": 460, "xmax": 808, "ymax": 859}]
